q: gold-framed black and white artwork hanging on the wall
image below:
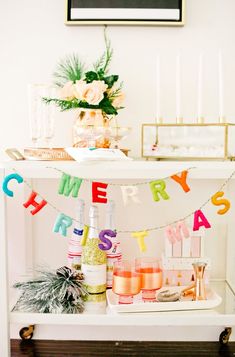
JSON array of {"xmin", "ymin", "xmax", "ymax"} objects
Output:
[{"xmin": 65, "ymin": 0, "xmax": 185, "ymax": 26}]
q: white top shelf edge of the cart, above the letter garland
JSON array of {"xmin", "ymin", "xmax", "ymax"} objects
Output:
[{"xmin": 0, "ymin": 160, "xmax": 235, "ymax": 180}]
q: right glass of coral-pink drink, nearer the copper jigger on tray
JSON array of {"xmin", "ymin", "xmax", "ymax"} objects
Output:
[{"xmin": 135, "ymin": 257, "xmax": 162, "ymax": 301}]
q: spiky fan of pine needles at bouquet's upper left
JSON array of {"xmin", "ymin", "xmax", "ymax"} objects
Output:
[{"xmin": 53, "ymin": 53, "xmax": 85, "ymax": 87}]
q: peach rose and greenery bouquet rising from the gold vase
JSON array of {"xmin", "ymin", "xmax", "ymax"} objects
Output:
[{"xmin": 43, "ymin": 31, "xmax": 124, "ymax": 117}]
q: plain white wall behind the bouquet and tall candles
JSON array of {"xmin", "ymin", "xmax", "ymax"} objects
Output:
[{"xmin": 0, "ymin": 0, "xmax": 235, "ymax": 156}]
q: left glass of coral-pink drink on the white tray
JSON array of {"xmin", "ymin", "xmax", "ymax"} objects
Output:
[{"xmin": 112, "ymin": 260, "xmax": 141, "ymax": 304}]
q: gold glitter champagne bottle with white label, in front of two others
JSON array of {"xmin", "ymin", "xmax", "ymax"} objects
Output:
[{"xmin": 81, "ymin": 205, "xmax": 107, "ymax": 294}]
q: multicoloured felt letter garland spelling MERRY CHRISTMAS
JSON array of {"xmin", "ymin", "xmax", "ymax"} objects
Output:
[{"xmin": 2, "ymin": 168, "xmax": 235, "ymax": 252}]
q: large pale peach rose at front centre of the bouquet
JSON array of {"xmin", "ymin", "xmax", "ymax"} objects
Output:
[{"xmin": 75, "ymin": 80, "xmax": 108, "ymax": 105}]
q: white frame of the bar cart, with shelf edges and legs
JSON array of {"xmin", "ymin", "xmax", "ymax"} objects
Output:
[{"xmin": 0, "ymin": 161, "xmax": 235, "ymax": 357}]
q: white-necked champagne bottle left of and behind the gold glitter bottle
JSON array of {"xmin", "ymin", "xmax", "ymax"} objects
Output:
[{"xmin": 68, "ymin": 199, "xmax": 85, "ymax": 270}]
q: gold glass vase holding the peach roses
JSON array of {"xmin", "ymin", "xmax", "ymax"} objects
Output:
[{"xmin": 73, "ymin": 108, "xmax": 111, "ymax": 148}]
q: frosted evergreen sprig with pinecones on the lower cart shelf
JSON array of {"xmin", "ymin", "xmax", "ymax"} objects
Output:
[{"xmin": 13, "ymin": 266, "xmax": 88, "ymax": 314}]
